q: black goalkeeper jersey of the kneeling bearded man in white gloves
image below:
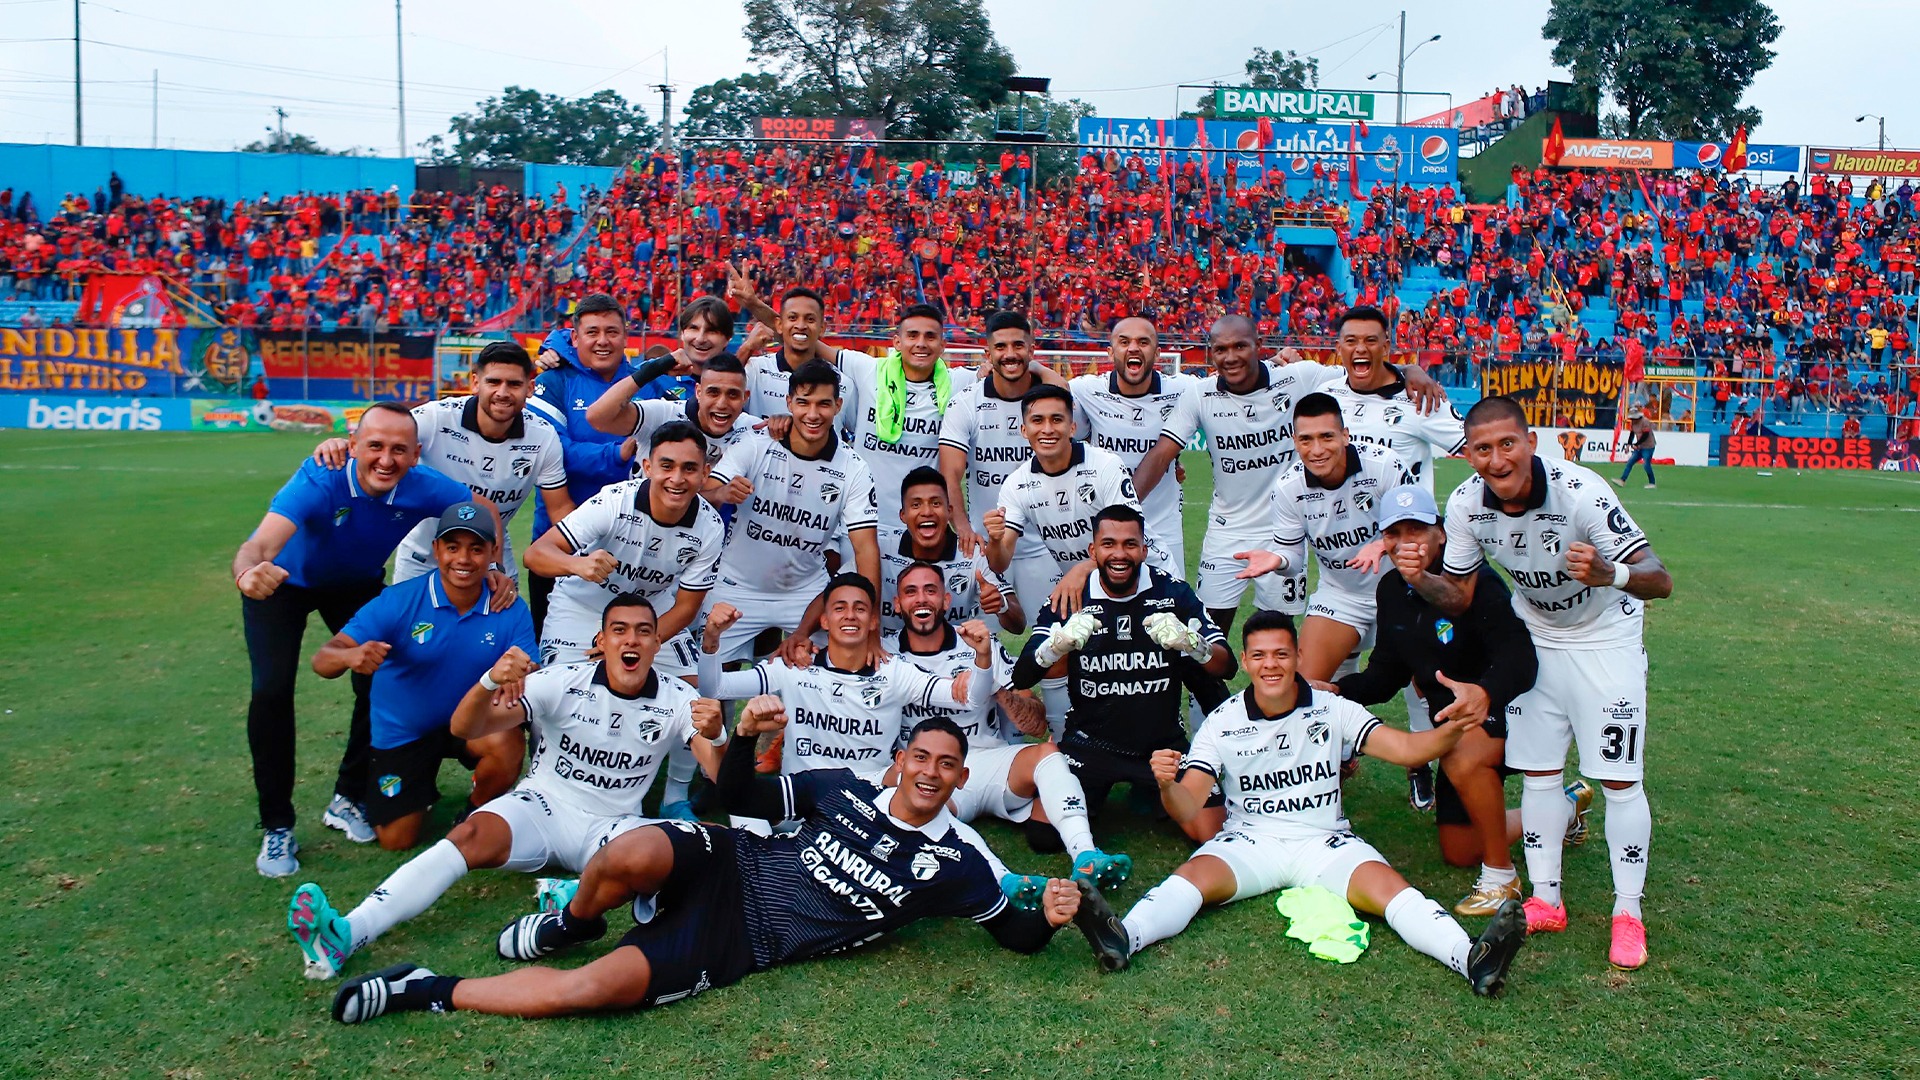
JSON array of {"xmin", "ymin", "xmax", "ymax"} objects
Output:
[{"xmin": 1014, "ymin": 565, "xmax": 1231, "ymax": 757}]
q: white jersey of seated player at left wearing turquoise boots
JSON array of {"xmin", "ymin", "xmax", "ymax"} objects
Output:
[{"xmin": 520, "ymin": 663, "xmax": 699, "ymax": 817}]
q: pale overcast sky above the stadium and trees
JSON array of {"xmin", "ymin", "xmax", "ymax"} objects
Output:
[{"xmin": 0, "ymin": 0, "xmax": 1920, "ymax": 154}]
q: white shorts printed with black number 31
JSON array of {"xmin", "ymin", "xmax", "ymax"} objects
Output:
[{"xmin": 1507, "ymin": 642, "xmax": 1647, "ymax": 782}]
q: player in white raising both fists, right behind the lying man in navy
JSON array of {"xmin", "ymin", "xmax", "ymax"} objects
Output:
[{"xmin": 701, "ymin": 573, "xmax": 995, "ymax": 780}]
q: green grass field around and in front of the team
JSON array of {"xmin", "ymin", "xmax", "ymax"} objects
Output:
[{"xmin": 0, "ymin": 430, "xmax": 1920, "ymax": 1076}]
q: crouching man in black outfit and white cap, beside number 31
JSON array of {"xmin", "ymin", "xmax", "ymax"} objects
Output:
[{"xmin": 1344, "ymin": 484, "xmax": 1551, "ymax": 915}]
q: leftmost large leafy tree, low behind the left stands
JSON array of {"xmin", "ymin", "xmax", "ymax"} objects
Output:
[{"xmin": 436, "ymin": 86, "xmax": 659, "ymax": 165}]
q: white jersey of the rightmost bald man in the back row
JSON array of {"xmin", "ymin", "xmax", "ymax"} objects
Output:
[{"xmin": 1156, "ymin": 359, "xmax": 1346, "ymax": 532}]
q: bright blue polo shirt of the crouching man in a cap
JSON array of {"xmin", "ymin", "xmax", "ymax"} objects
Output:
[{"xmin": 340, "ymin": 571, "xmax": 540, "ymax": 749}]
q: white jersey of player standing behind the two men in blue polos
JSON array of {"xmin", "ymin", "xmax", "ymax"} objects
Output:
[{"xmin": 394, "ymin": 396, "xmax": 566, "ymax": 582}]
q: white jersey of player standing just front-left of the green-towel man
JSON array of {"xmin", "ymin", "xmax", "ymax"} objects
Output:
[{"xmin": 712, "ymin": 432, "xmax": 879, "ymax": 592}]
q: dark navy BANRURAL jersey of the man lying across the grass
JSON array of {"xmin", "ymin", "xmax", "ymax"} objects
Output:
[{"xmin": 716, "ymin": 738, "xmax": 1052, "ymax": 969}]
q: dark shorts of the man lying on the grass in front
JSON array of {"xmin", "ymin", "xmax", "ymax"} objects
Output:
[{"xmin": 620, "ymin": 821, "xmax": 756, "ymax": 1009}]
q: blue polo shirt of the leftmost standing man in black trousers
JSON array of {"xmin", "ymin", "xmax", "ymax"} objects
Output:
[{"xmin": 267, "ymin": 457, "xmax": 474, "ymax": 588}]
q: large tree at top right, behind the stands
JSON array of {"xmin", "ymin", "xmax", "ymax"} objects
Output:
[{"xmin": 1540, "ymin": 0, "xmax": 1780, "ymax": 140}]
